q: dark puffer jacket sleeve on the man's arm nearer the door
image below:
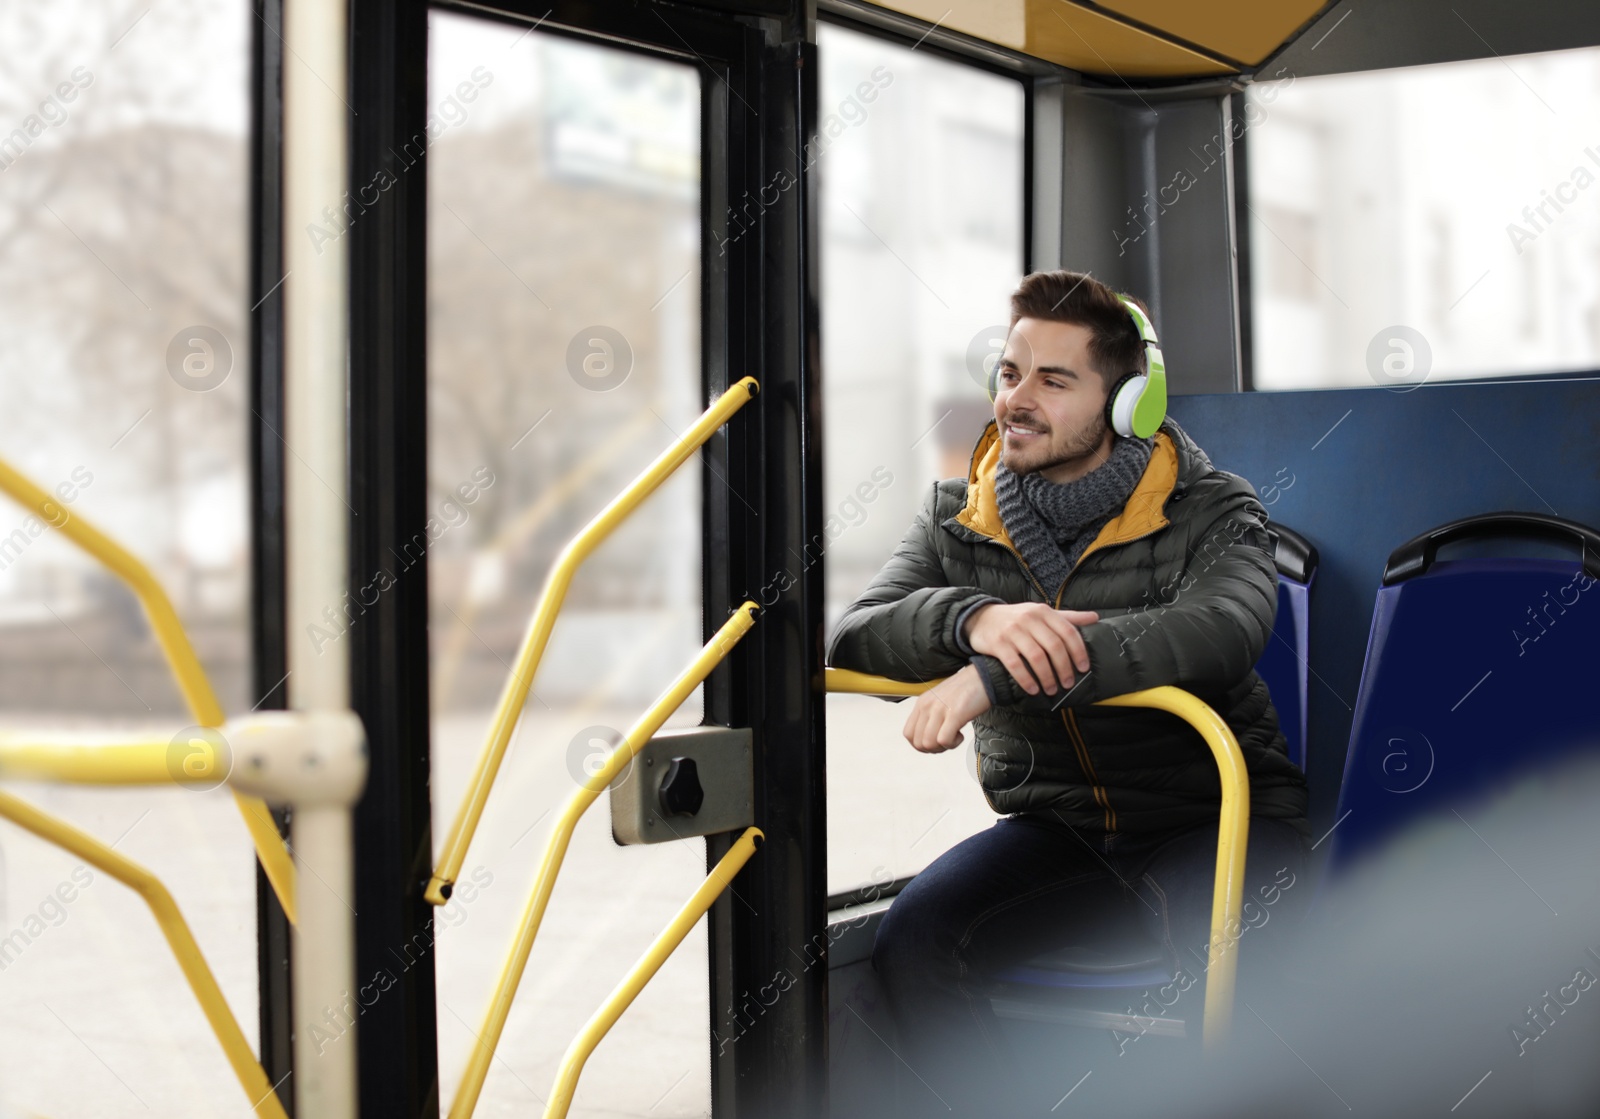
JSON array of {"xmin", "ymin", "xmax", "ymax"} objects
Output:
[{"xmin": 827, "ymin": 483, "xmax": 998, "ymax": 680}]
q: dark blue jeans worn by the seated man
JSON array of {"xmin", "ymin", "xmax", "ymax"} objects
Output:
[{"xmin": 872, "ymin": 813, "xmax": 1310, "ymax": 1116}]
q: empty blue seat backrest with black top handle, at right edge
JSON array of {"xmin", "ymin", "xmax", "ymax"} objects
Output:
[{"xmin": 1330, "ymin": 514, "xmax": 1600, "ymax": 868}]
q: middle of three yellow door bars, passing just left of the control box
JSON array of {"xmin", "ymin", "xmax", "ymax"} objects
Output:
[{"xmin": 450, "ymin": 602, "xmax": 760, "ymax": 1119}]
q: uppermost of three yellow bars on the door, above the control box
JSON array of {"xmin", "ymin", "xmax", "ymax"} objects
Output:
[{"xmin": 422, "ymin": 376, "xmax": 758, "ymax": 906}]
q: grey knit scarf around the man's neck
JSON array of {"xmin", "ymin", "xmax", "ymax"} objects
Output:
[{"xmin": 995, "ymin": 435, "xmax": 1155, "ymax": 594}]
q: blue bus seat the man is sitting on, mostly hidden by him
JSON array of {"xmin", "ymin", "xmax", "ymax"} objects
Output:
[{"xmin": 995, "ymin": 523, "xmax": 1317, "ymax": 1025}]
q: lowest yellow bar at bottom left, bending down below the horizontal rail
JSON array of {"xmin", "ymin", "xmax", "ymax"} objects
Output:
[{"xmin": 0, "ymin": 792, "xmax": 286, "ymax": 1119}]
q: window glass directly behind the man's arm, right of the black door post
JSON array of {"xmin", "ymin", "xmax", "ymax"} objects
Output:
[{"xmin": 808, "ymin": 26, "xmax": 1022, "ymax": 893}]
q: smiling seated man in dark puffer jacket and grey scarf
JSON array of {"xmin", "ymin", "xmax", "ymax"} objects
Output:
[{"xmin": 829, "ymin": 272, "xmax": 1307, "ymax": 1116}]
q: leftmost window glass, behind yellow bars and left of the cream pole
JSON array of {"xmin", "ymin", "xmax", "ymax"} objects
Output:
[{"xmin": 0, "ymin": 0, "xmax": 258, "ymax": 1119}]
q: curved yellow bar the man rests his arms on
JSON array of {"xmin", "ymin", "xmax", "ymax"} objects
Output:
[{"xmin": 822, "ymin": 668, "xmax": 1250, "ymax": 1049}]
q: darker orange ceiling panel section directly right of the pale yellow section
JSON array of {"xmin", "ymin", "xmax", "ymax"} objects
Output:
[{"xmin": 1022, "ymin": 0, "xmax": 1234, "ymax": 78}]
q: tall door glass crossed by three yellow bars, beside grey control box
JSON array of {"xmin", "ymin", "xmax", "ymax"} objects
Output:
[{"xmin": 426, "ymin": 11, "xmax": 710, "ymax": 1116}]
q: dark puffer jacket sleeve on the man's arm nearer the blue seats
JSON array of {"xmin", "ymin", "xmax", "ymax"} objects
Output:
[{"xmin": 976, "ymin": 493, "xmax": 1278, "ymax": 712}]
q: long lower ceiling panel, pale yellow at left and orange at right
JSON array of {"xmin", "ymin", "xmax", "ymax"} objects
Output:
[{"xmin": 874, "ymin": 0, "xmax": 1235, "ymax": 78}]
